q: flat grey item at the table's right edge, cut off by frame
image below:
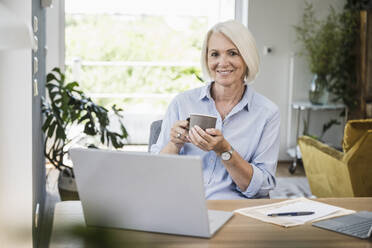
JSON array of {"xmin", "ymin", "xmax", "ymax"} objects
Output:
[{"xmin": 312, "ymin": 211, "xmax": 372, "ymax": 239}]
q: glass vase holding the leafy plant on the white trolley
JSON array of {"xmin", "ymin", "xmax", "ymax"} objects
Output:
[{"xmin": 309, "ymin": 74, "xmax": 329, "ymax": 105}]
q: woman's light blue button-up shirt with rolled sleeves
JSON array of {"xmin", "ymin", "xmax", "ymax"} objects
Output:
[{"xmin": 151, "ymin": 83, "xmax": 280, "ymax": 199}]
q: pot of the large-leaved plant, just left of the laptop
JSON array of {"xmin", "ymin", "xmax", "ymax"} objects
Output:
[{"xmin": 58, "ymin": 169, "xmax": 79, "ymax": 201}]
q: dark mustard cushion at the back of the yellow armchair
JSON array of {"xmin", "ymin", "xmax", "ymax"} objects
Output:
[{"xmin": 342, "ymin": 119, "xmax": 372, "ymax": 153}]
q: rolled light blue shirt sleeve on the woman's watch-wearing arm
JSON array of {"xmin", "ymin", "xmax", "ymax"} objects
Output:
[{"xmin": 236, "ymin": 109, "xmax": 280, "ymax": 198}]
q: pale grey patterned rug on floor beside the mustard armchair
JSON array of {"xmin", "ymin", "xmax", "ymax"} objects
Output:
[{"xmin": 269, "ymin": 177, "xmax": 315, "ymax": 199}]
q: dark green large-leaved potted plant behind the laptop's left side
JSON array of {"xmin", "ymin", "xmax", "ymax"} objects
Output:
[{"xmin": 42, "ymin": 68, "xmax": 128, "ymax": 200}]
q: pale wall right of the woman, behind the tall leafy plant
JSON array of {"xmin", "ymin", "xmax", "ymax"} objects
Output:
[{"xmin": 248, "ymin": 0, "xmax": 345, "ymax": 160}]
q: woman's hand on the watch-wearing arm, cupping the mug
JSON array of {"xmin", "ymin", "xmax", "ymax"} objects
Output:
[{"xmin": 189, "ymin": 126, "xmax": 230, "ymax": 155}]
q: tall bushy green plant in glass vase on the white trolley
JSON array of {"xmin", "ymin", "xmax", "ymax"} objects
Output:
[{"xmin": 294, "ymin": 2, "xmax": 358, "ymax": 109}]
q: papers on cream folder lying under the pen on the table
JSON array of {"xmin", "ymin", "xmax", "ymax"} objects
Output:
[{"xmin": 234, "ymin": 197, "xmax": 355, "ymax": 227}]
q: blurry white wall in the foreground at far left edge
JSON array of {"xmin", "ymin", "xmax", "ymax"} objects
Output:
[{"xmin": 0, "ymin": 0, "xmax": 32, "ymax": 247}]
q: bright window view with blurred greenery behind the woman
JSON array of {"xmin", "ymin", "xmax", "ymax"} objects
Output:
[{"xmin": 65, "ymin": 0, "xmax": 235, "ymax": 144}]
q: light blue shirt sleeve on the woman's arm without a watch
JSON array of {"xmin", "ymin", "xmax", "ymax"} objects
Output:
[{"xmin": 150, "ymin": 98, "xmax": 179, "ymax": 154}]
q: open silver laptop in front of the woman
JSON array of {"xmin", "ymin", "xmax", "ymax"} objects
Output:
[{"xmin": 69, "ymin": 148, "xmax": 233, "ymax": 238}]
